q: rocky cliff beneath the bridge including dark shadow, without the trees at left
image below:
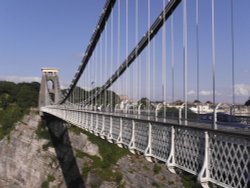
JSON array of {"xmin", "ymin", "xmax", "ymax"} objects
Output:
[{"xmin": 0, "ymin": 113, "xmax": 186, "ymax": 188}]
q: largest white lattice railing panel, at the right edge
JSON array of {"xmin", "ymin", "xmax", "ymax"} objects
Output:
[{"xmin": 209, "ymin": 132, "xmax": 250, "ymax": 188}]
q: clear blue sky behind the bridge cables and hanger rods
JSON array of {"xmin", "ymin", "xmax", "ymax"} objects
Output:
[{"xmin": 0, "ymin": 0, "xmax": 250, "ymax": 103}]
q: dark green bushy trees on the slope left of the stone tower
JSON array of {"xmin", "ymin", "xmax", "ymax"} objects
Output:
[{"xmin": 0, "ymin": 81, "xmax": 40, "ymax": 140}]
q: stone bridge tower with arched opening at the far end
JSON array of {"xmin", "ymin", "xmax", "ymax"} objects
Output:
[{"xmin": 39, "ymin": 68, "xmax": 61, "ymax": 107}]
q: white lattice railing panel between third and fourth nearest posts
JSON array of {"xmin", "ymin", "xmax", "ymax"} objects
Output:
[{"xmin": 134, "ymin": 121, "xmax": 149, "ymax": 152}]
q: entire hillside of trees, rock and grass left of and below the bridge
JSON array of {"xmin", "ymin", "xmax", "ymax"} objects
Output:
[{"xmin": 0, "ymin": 82, "xmax": 199, "ymax": 188}]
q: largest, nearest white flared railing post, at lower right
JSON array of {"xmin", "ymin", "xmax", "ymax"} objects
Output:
[{"xmin": 198, "ymin": 131, "xmax": 210, "ymax": 188}]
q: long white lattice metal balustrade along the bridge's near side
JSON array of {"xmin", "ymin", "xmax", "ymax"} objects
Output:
[{"xmin": 41, "ymin": 106, "xmax": 250, "ymax": 188}]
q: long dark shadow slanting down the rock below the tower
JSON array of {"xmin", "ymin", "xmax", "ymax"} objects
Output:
[{"xmin": 44, "ymin": 115, "xmax": 85, "ymax": 188}]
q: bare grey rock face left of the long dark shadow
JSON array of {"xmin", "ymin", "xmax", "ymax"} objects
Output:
[{"xmin": 0, "ymin": 111, "xmax": 60, "ymax": 187}]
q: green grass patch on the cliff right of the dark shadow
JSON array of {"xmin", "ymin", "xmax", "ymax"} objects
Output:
[{"xmin": 70, "ymin": 127, "xmax": 129, "ymax": 187}]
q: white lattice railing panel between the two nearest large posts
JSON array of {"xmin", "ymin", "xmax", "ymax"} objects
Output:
[{"xmin": 175, "ymin": 128, "xmax": 205, "ymax": 174}]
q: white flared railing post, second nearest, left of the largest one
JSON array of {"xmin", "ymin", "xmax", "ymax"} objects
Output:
[{"xmin": 167, "ymin": 127, "xmax": 175, "ymax": 173}]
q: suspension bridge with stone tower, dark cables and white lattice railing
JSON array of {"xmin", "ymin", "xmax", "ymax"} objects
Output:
[{"xmin": 39, "ymin": 0, "xmax": 250, "ymax": 188}]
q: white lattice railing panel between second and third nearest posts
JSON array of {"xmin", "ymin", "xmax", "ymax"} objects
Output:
[{"xmin": 151, "ymin": 124, "xmax": 171, "ymax": 161}]
